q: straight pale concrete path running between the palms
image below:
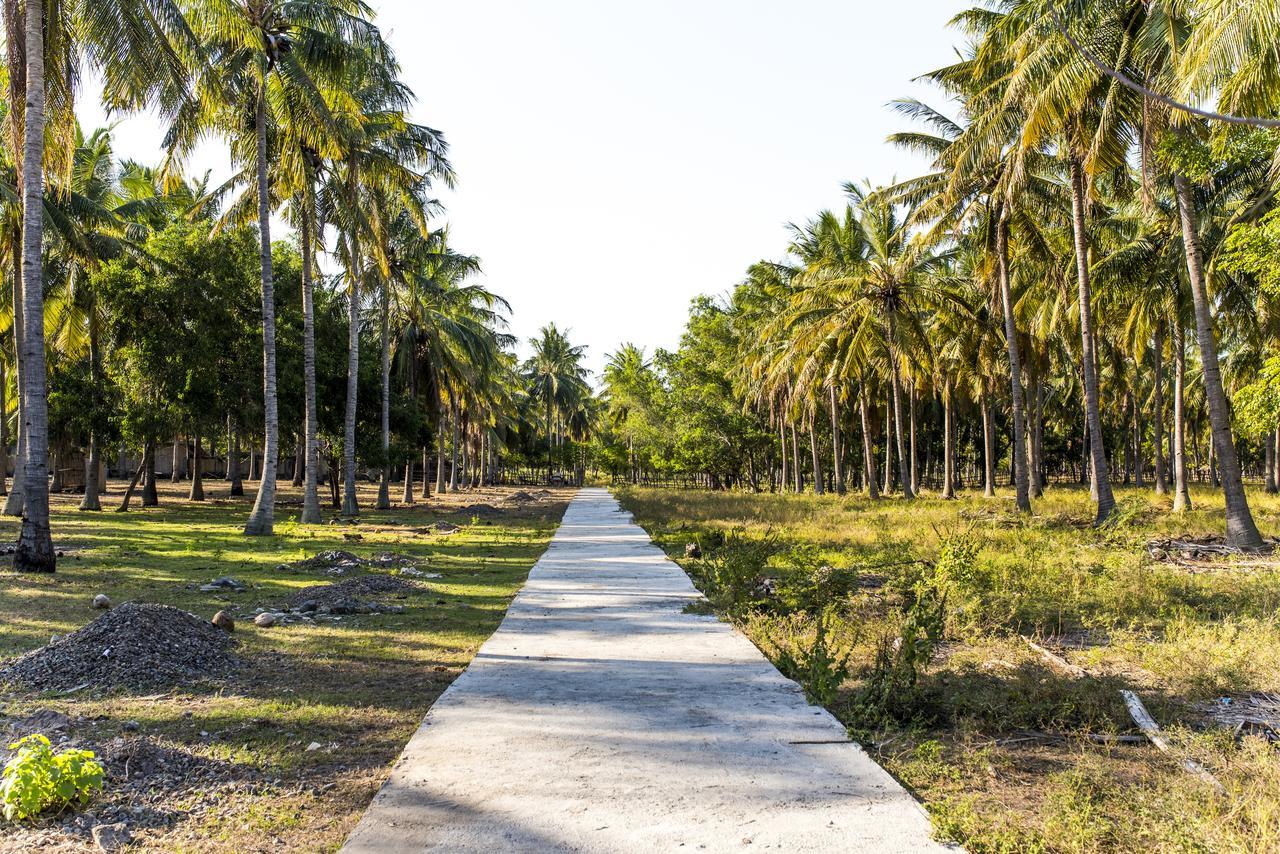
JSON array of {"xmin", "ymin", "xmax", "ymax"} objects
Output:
[{"xmin": 343, "ymin": 489, "xmax": 945, "ymax": 854}]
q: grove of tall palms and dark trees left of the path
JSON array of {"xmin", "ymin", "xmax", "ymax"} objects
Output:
[{"xmin": 0, "ymin": 0, "xmax": 591, "ymax": 571}]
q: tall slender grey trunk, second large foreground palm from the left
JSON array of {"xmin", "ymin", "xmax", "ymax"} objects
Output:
[{"xmin": 244, "ymin": 88, "xmax": 280, "ymax": 535}]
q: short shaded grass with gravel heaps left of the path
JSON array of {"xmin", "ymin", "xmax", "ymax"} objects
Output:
[{"xmin": 0, "ymin": 481, "xmax": 570, "ymax": 851}]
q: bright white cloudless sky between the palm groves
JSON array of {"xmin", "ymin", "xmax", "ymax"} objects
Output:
[{"xmin": 82, "ymin": 0, "xmax": 969, "ymax": 381}]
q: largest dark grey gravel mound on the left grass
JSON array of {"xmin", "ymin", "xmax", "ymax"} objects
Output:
[{"xmin": 0, "ymin": 602, "xmax": 238, "ymax": 690}]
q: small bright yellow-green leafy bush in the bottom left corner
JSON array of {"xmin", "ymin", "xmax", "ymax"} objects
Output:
[{"xmin": 0, "ymin": 734, "xmax": 102, "ymax": 821}]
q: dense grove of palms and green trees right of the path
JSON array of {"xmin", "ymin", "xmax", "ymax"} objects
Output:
[{"xmin": 605, "ymin": 0, "xmax": 1280, "ymax": 548}]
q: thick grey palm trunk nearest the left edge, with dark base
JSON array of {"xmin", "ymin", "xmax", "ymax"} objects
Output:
[{"xmin": 13, "ymin": 3, "xmax": 58, "ymax": 572}]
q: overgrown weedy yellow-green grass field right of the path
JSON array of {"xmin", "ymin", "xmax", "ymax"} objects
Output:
[{"xmin": 621, "ymin": 488, "xmax": 1280, "ymax": 853}]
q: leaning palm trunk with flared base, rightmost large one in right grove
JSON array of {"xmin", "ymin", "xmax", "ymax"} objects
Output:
[{"xmin": 1174, "ymin": 174, "xmax": 1262, "ymax": 551}]
